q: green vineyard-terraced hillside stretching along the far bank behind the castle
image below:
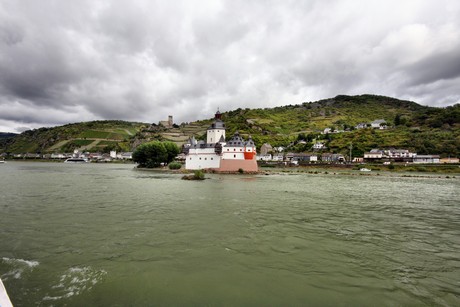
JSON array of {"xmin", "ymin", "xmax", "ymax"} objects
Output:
[{"xmin": 0, "ymin": 95, "xmax": 460, "ymax": 156}]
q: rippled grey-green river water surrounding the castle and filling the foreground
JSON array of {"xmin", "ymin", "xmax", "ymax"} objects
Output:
[{"xmin": 0, "ymin": 162, "xmax": 460, "ymax": 306}]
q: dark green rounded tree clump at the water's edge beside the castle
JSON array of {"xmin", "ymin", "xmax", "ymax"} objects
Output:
[{"xmin": 133, "ymin": 141, "xmax": 179, "ymax": 168}]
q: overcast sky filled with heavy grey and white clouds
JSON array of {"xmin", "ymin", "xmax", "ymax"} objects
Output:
[{"xmin": 0, "ymin": 0, "xmax": 460, "ymax": 132}]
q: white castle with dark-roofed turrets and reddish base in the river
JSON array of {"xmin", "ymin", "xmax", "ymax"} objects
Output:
[{"xmin": 184, "ymin": 111, "xmax": 258, "ymax": 172}]
